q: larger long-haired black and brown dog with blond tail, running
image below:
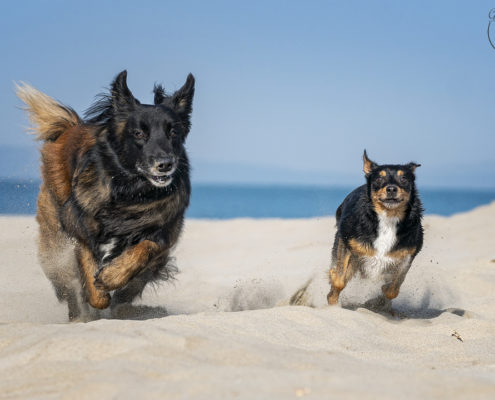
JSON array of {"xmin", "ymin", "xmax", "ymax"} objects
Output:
[{"xmin": 17, "ymin": 71, "xmax": 194, "ymax": 320}]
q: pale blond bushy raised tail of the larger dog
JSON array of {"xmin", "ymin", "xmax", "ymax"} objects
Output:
[{"xmin": 15, "ymin": 82, "xmax": 81, "ymax": 141}]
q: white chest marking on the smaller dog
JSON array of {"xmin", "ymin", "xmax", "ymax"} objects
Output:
[{"xmin": 364, "ymin": 213, "xmax": 399, "ymax": 278}]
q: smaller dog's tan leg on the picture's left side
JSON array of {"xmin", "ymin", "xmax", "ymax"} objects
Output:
[{"xmin": 327, "ymin": 239, "xmax": 355, "ymax": 305}]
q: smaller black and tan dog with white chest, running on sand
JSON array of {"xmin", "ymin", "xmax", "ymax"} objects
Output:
[{"xmin": 327, "ymin": 150, "xmax": 423, "ymax": 305}]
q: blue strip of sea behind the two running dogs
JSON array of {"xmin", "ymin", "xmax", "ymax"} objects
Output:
[{"xmin": 0, "ymin": 180, "xmax": 495, "ymax": 219}]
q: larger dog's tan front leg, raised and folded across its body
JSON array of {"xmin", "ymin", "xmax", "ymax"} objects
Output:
[{"xmin": 94, "ymin": 240, "xmax": 162, "ymax": 291}]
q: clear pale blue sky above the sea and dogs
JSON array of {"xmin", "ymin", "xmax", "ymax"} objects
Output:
[{"xmin": 0, "ymin": 0, "xmax": 495, "ymax": 188}]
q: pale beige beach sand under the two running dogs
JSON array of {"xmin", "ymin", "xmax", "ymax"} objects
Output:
[{"xmin": 0, "ymin": 203, "xmax": 495, "ymax": 399}]
